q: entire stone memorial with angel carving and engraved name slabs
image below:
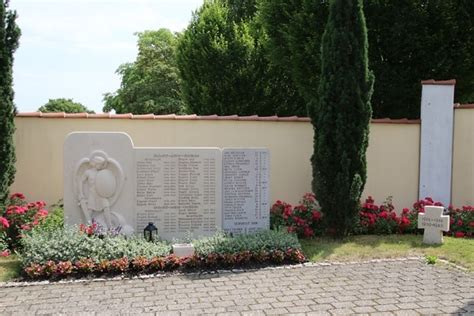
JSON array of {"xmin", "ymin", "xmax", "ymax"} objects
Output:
[{"xmin": 64, "ymin": 132, "xmax": 270, "ymax": 240}]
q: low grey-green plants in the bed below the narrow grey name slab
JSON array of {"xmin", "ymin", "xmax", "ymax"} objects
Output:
[{"xmin": 193, "ymin": 230, "xmax": 301, "ymax": 257}]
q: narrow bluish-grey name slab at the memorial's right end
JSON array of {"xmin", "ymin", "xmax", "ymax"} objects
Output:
[{"xmin": 222, "ymin": 148, "xmax": 270, "ymax": 234}]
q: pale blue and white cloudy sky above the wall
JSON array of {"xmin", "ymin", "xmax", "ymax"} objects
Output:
[{"xmin": 10, "ymin": 0, "xmax": 203, "ymax": 113}]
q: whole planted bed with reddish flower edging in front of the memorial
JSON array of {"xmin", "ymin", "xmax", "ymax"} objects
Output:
[{"xmin": 21, "ymin": 227, "xmax": 305, "ymax": 278}]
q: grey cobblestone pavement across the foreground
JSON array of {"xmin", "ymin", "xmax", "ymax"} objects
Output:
[{"xmin": 0, "ymin": 259, "xmax": 474, "ymax": 315}]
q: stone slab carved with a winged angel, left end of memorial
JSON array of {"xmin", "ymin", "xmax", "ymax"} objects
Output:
[{"xmin": 64, "ymin": 132, "xmax": 135, "ymax": 233}]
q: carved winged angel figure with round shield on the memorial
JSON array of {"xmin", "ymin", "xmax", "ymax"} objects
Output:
[{"xmin": 74, "ymin": 150, "xmax": 133, "ymax": 233}]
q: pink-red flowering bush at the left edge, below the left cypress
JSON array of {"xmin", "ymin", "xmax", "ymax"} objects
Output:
[{"xmin": 0, "ymin": 193, "xmax": 48, "ymax": 255}]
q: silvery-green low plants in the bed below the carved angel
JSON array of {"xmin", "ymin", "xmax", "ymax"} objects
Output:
[{"xmin": 21, "ymin": 226, "xmax": 171, "ymax": 267}]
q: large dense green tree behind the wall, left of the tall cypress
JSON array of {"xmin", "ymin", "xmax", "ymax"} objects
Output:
[{"xmin": 178, "ymin": 0, "xmax": 306, "ymax": 116}]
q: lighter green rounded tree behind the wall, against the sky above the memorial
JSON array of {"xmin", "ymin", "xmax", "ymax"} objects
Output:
[{"xmin": 103, "ymin": 29, "xmax": 187, "ymax": 114}]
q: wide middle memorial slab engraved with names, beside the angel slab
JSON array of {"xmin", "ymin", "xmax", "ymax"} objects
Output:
[{"xmin": 135, "ymin": 148, "xmax": 222, "ymax": 240}]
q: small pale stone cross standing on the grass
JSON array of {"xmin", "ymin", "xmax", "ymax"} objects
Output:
[{"xmin": 418, "ymin": 206, "xmax": 449, "ymax": 244}]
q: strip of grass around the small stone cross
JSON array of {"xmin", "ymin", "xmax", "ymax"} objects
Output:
[{"xmin": 301, "ymin": 235, "xmax": 474, "ymax": 271}]
